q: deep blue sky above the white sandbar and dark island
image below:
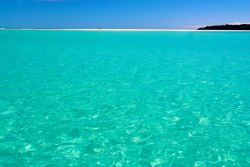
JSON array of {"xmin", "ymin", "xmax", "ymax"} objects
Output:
[{"xmin": 0, "ymin": 0, "xmax": 250, "ymax": 29}]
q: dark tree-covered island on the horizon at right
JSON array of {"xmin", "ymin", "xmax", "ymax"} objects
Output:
[{"xmin": 198, "ymin": 24, "xmax": 250, "ymax": 30}]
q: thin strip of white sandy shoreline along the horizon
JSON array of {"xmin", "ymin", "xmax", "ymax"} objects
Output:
[{"xmin": 0, "ymin": 28, "xmax": 250, "ymax": 32}]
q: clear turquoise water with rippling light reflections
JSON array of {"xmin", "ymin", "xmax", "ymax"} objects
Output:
[{"xmin": 0, "ymin": 30, "xmax": 250, "ymax": 167}]
